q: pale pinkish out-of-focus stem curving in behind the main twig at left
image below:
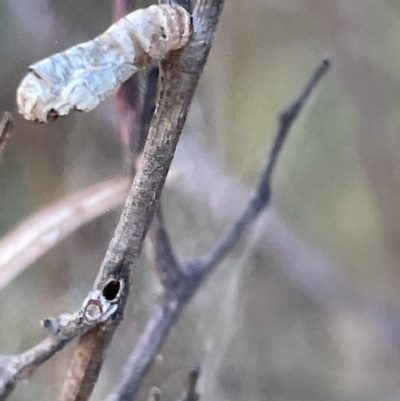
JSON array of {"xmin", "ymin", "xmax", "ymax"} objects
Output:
[{"xmin": 0, "ymin": 178, "xmax": 130, "ymax": 290}]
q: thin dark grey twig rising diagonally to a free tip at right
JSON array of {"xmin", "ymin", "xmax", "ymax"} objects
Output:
[{"xmin": 107, "ymin": 60, "xmax": 329, "ymax": 401}]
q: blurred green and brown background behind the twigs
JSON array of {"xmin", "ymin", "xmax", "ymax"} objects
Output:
[{"xmin": 0, "ymin": 0, "xmax": 400, "ymax": 401}]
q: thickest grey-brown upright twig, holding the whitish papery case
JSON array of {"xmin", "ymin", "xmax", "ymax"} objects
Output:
[{"xmin": 56, "ymin": 0, "xmax": 227, "ymax": 401}]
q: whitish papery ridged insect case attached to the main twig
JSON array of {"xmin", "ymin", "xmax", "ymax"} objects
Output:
[{"xmin": 17, "ymin": 4, "xmax": 191, "ymax": 122}]
